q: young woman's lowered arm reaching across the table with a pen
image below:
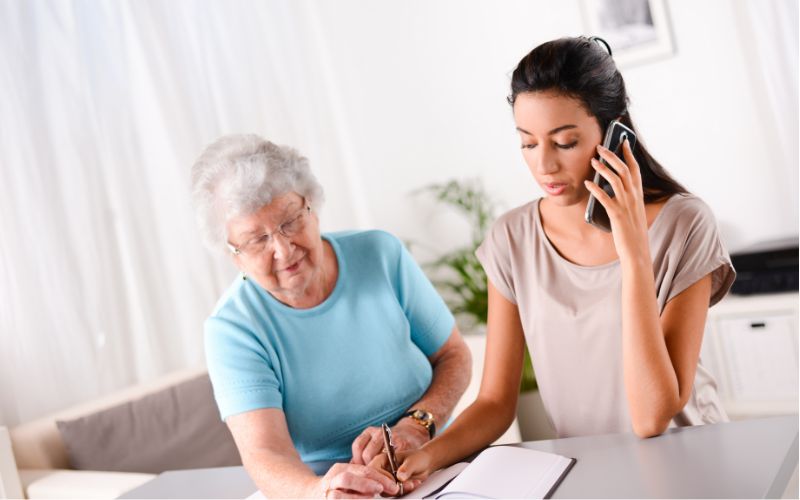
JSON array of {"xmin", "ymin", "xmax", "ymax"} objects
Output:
[{"xmin": 384, "ymin": 282, "xmax": 525, "ymax": 481}]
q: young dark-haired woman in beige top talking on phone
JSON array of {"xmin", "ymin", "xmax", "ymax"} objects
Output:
[{"xmin": 373, "ymin": 37, "xmax": 735, "ymax": 481}]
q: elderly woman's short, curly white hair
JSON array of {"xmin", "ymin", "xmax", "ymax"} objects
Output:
[{"xmin": 192, "ymin": 134, "xmax": 324, "ymax": 250}]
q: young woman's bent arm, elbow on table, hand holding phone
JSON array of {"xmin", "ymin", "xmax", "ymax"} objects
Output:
[{"xmin": 586, "ymin": 141, "xmax": 711, "ymax": 437}]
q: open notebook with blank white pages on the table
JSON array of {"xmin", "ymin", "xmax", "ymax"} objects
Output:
[{"xmin": 408, "ymin": 446, "xmax": 575, "ymax": 498}]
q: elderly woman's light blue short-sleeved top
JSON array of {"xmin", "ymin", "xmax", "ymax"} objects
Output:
[{"xmin": 205, "ymin": 231, "xmax": 455, "ymax": 462}]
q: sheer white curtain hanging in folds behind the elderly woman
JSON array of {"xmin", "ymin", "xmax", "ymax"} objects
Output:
[{"xmin": 0, "ymin": 0, "xmax": 369, "ymax": 425}]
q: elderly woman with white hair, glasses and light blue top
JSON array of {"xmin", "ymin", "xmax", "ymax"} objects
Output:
[{"xmin": 192, "ymin": 135, "xmax": 471, "ymax": 497}]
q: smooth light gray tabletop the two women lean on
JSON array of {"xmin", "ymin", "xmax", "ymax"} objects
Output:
[{"xmin": 120, "ymin": 415, "xmax": 798, "ymax": 498}]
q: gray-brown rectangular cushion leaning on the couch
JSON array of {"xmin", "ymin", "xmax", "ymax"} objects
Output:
[{"xmin": 56, "ymin": 374, "xmax": 242, "ymax": 474}]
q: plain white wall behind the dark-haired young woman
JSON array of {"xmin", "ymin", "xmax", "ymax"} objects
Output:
[{"xmin": 312, "ymin": 0, "xmax": 798, "ymax": 256}]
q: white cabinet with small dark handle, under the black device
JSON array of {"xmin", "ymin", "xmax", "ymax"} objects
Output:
[{"xmin": 700, "ymin": 292, "xmax": 800, "ymax": 420}]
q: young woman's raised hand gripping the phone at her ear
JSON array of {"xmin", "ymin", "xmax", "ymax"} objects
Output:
[{"xmin": 584, "ymin": 135, "xmax": 650, "ymax": 265}]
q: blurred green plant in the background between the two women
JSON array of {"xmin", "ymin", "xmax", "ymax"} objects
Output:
[{"xmin": 416, "ymin": 179, "xmax": 537, "ymax": 393}]
